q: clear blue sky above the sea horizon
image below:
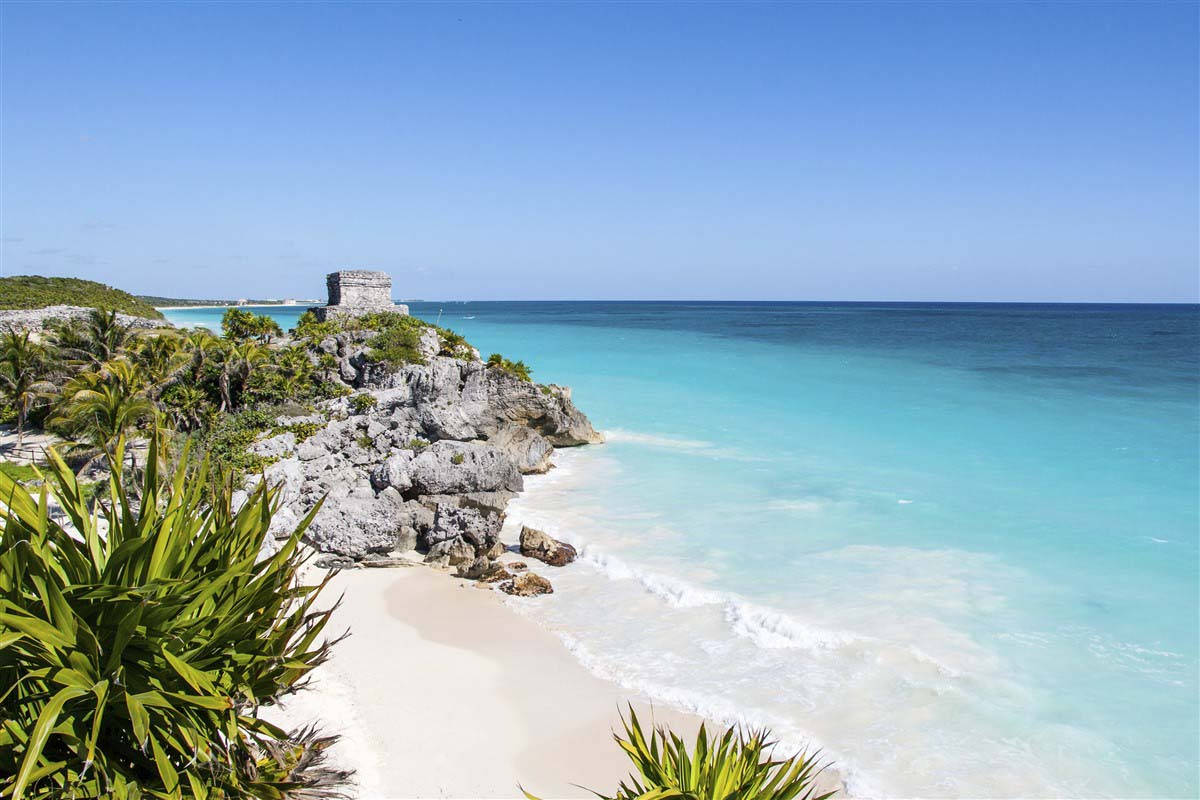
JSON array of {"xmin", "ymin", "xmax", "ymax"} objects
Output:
[{"xmin": 0, "ymin": 0, "xmax": 1200, "ymax": 301}]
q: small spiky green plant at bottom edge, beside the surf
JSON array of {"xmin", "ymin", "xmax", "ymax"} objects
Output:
[{"xmin": 524, "ymin": 706, "xmax": 834, "ymax": 800}]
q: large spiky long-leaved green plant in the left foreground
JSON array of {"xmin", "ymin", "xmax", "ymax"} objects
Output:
[{"xmin": 0, "ymin": 431, "xmax": 344, "ymax": 800}]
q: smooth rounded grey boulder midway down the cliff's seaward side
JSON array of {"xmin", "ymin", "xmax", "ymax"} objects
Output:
[{"xmin": 408, "ymin": 440, "xmax": 524, "ymax": 494}]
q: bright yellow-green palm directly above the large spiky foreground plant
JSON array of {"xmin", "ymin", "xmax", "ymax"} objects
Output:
[{"xmin": 50, "ymin": 359, "xmax": 158, "ymax": 467}]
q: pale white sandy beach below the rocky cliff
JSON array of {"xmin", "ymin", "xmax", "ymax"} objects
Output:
[{"xmin": 274, "ymin": 567, "xmax": 700, "ymax": 799}]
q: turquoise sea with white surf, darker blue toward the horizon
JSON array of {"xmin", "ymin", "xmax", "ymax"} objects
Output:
[{"xmin": 168, "ymin": 302, "xmax": 1200, "ymax": 798}]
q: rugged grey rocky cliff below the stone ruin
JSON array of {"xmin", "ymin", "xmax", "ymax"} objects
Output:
[{"xmin": 241, "ymin": 330, "xmax": 602, "ymax": 585}]
